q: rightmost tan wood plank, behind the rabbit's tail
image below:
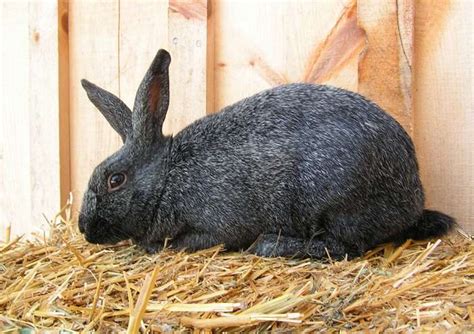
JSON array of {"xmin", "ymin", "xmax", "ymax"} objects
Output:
[{"xmin": 415, "ymin": 0, "xmax": 474, "ymax": 233}]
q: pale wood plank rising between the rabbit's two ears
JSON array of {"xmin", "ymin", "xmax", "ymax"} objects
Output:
[{"xmin": 119, "ymin": 0, "xmax": 169, "ymax": 109}]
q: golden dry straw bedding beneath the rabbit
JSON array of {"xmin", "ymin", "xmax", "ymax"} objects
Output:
[{"xmin": 0, "ymin": 198, "xmax": 474, "ymax": 333}]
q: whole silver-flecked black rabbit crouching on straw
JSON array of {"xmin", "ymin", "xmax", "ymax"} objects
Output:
[{"xmin": 79, "ymin": 50, "xmax": 455, "ymax": 260}]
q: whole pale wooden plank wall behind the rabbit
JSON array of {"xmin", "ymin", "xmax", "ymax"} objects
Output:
[{"xmin": 0, "ymin": 0, "xmax": 474, "ymax": 240}]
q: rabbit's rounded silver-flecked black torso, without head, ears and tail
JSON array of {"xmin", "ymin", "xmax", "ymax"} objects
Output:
[{"xmin": 168, "ymin": 84, "xmax": 423, "ymax": 248}]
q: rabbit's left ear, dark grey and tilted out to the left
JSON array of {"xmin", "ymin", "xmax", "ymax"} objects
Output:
[{"xmin": 81, "ymin": 79, "xmax": 132, "ymax": 142}]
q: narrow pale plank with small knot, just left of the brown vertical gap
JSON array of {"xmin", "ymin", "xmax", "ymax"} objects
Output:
[{"xmin": 28, "ymin": 0, "xmax": 61, "ymax": 230}]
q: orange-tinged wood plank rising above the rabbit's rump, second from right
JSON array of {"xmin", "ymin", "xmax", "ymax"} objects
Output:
[{"xmin": 357, "ymin": 0, "xmax": 414, "ymax": 134}]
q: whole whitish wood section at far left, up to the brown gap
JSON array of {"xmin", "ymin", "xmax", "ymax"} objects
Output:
[{"xmin": 0, "ymin": 0, "xmax": 60, "ymax": 240}]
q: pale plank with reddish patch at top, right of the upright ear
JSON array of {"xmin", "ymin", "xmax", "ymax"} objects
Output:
[{"xmin": 164, "ymin": 0, "xmax": 214, "ymax": 133}]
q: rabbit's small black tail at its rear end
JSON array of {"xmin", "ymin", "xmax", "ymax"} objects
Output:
[{"xmin": 408, "ymin": 210, "xmax": 456, "ymax": 240}]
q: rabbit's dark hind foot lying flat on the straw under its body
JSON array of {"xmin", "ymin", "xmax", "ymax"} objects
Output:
[{"xmin": 248, "ymin": 234, "xmax": 358, "ymax": 260}]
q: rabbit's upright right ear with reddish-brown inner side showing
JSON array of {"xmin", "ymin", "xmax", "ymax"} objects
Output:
[{"xmin": 132, "ymin": 49, "xmax": 171, "ymax": 141}]
